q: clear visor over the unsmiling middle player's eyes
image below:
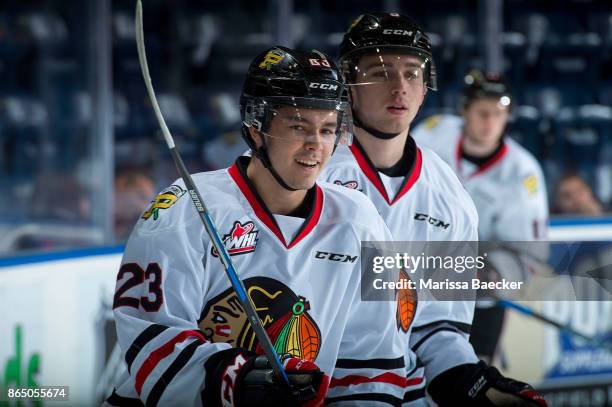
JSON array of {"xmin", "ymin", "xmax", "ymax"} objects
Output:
[{"xmin": 349, "ymin": 52, "xmax": 427, "ymax": 89}]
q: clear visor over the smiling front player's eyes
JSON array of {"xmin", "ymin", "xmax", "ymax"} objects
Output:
[{"xmin": 247, "ymin": 97, "xmax": 353, "ymax": 145}]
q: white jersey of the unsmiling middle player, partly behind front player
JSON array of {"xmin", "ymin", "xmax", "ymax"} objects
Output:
[{"xmin": 320, "ymin": 138, "xmax": 478, "ymax": 406}]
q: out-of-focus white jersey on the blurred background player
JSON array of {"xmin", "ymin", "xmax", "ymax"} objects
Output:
[{"xmin": 413, "ymin": 115, "xmax": 548, "ymax": 241}]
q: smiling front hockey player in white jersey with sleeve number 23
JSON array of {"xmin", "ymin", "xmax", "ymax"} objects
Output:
[{"xmin": 107, "ymin": 47, "xmax": 406, "ymax": 406}]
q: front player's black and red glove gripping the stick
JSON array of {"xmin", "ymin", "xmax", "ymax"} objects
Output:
[{"xmin": 204, "ymin": 348, "xmax": 328, "ymax": 407}]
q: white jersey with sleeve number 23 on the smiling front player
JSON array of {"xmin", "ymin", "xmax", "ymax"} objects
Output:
[{"xmin": 107, "ymin": 157, "xmax": 408, "ymax": 406}]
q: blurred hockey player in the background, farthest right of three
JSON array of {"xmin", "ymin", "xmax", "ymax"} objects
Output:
[{"xmin": 413, "ymin": 70, "xmax": 548, "ymax": 361}]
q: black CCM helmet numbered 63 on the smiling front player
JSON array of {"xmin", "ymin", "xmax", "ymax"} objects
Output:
[{"xmin": 240, "ymin": 46, "xmax": 352, "ymax": 190}]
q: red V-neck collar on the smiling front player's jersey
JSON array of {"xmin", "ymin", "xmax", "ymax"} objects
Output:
[{"xmin": 228, "ymin": 157, "xmax": 323, "ymax": 249}]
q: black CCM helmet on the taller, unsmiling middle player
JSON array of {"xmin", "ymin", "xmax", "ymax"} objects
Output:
[{"xmin": 340, "ymin": 13, "xmax": 437, "ymax": 90}]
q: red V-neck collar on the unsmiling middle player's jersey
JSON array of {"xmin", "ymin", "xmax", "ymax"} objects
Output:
[{"xmin": 349, "ymin": 136, "xmax": 423, "ymax": 205}]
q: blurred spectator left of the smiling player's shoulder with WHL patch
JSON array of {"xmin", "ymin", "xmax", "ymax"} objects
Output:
[{"xmin": 115, "ymin": 167, "xmax": 155, "ymax": 242}]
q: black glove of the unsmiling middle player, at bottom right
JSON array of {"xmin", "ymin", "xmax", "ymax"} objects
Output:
[{"xmin": 427, "ymin": 361, "xmax": 548, "ymax": 407}]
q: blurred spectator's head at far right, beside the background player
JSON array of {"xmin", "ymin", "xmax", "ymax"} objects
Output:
[{"xmin": 553, "ymin": 172, "xmax": 604, "ymax": 216}]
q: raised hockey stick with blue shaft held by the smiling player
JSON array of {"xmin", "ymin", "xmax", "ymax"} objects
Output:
[{"xmin": 136, "ymin": 0, "xmax": 290, "ymax": 386}]
